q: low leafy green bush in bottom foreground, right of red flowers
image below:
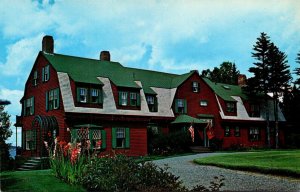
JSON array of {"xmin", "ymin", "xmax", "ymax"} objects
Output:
[{"xmin": 82, "ymin": 156, "xmax": 185, "ymax": 191}]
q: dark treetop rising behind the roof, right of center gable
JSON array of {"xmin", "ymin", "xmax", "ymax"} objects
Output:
[{"xmin": 202, "ymin": 61, "xmax": 240, "ymax": 85}]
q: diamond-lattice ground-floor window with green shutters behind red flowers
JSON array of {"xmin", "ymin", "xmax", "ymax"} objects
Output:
[{"xmin": 71, "ymin": 128, "xmax": 106, "ymax": 149}]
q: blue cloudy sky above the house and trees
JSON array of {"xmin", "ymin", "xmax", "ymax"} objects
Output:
[{"xmin": 0, "ymin": 0, "xmax": 300, "ymax": 143}]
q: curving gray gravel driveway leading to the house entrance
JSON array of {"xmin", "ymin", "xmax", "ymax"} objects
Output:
[{"xmin": 153, "ymin": 153, "xmax": 300, "ymax": 191}]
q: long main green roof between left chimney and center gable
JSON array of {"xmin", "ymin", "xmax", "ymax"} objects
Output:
[{"xmin": 42, "ymin": 52, "xmax": 193, "ymax": 91}]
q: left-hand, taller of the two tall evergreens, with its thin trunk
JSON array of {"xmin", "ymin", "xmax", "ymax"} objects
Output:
[{"xmin": 247, "ymin": 33, "xmax": 271, "ymax": 147}]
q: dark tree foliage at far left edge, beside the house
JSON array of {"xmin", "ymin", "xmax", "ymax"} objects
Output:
[{"xmin": 0, "ymin": 105, "xmax": 12, "ymax": 171}]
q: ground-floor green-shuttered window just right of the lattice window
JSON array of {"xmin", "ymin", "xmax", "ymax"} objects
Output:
[{"xmin": 112, "ymin": 127, "xmax": 130, "ymax": 148}]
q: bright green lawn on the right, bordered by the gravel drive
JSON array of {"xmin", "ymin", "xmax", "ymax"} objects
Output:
[{"xmin": 194, "ymin": 150, "xmax": 300, "ymax": 177}]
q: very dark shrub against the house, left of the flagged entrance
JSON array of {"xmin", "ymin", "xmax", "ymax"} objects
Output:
[{"xmin": 149, "ymin": 131, "xmax": 192, "ymax": 155}]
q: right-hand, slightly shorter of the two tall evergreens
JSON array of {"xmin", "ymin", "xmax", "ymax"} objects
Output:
[{"xmin": 267, "ymin": 43, "xmax": 291, "ymax": 148}]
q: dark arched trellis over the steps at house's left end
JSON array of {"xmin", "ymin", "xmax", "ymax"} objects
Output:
[{"xmin": 32, "ymin": 115, "xmax": 58, "ymax": 157}]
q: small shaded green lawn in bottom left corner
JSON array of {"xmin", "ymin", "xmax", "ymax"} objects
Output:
[{"xmin": 0, "ymin": 170, "xmax": 85, "ymax": 192}]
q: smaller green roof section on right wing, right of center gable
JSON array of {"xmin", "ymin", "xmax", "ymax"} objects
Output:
[{"xmin": 203, "ymin": 78, "xmax": 248, "ymax": 101}]
